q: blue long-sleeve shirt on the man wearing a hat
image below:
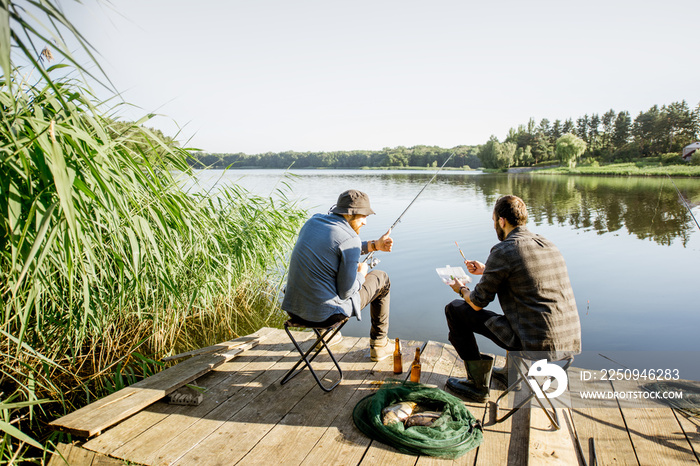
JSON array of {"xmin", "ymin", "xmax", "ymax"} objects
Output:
[{"xmin": 282, "ymin": 214, "xmax": 367, "ymax": 322}]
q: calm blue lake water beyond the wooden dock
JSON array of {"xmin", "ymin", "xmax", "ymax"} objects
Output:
[{"xmin": 191, "ymin": 170, "xmax": 700, "ymax": 380}]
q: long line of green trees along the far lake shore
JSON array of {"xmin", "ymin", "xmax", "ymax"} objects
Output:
[{"xmin": 183, "ymin": 100, "xmax": 700, "ymax": 169}]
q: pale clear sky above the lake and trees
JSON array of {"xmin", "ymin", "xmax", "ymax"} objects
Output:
[{"xmin": 64, "ymin": 0, "xmax": 700, "ymax": 154}]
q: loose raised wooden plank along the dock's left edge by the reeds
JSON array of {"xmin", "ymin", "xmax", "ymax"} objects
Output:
[{"xmin": 50, "ymin": 339, "xmax": 259, "ymax": 437}]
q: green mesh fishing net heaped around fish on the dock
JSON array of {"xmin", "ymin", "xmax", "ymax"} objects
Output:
[{"xmin": 352, "ymin": 381, "xmax": 484, "ymax": 459}]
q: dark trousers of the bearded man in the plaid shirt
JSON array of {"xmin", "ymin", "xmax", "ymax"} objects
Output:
[{"xmin": 445, "ymin": 299, "xmax": 522, "ymax": 361}]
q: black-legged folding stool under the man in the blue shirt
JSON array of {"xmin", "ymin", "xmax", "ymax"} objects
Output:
[{"xmin": 280, "ymin": 314, "xmax": 349, "ymax": 392}]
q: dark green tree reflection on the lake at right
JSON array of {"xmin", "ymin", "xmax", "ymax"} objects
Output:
[{"xmin": 446, "ymin": 174, "xmax": 700, "ymax": 246}]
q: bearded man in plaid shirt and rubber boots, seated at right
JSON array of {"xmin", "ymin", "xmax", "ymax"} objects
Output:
[{"xmin": 445, "ymin": 196, "xmax": 581, "ymax": 402}]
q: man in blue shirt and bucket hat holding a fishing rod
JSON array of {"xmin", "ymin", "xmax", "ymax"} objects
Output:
[{"xmin": 282, "ymin": 189, "xmax": 394, "ymax": 361}]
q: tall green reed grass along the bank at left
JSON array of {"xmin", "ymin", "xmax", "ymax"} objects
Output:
[{"xmin": 0, "ymin": 67, "xmax": 305, "ymax": 463}]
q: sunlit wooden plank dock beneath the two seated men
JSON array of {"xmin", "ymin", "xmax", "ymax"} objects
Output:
[{"xmin": 49, "ymin": 328, "xmax": 700, "ymax": 466}]
